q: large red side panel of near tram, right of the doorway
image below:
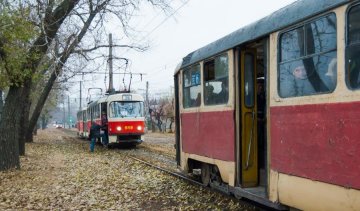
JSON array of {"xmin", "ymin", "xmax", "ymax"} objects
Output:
[{"xmin": 271, "ymin": 102, "xmax": 360, "ymax": 189}]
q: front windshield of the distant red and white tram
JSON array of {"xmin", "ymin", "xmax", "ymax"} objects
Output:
[{"xmin": 109, "ymin": 101, "xmax": 144, "ymax": 118}]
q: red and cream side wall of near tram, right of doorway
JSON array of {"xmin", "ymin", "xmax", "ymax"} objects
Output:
[{"xmin": 269, "ymin": 6, "xmax": 360, "ymax": 210}]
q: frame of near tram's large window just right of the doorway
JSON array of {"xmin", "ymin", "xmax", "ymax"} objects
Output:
[{"xmin": 276, "ymin": 11, "xmax": 339, "ymax": 99}]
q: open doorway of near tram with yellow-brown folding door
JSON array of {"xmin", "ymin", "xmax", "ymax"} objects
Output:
[{"xmin": 235, "ymin": 39, "xmax": 268, "ymax": 198}]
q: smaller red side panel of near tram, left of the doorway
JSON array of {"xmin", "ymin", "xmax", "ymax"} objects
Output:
[{"xmin": 181, "ymin": 111, "xmax": 235, "ymax": 161}]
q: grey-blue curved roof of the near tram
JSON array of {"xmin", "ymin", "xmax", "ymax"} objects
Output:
[{"xmin": 175, "ymin": 0, "xmax": 348, "ymax": 75}]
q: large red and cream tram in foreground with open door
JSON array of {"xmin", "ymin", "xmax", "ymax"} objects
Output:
[{"xmin": 174, "ymin": 0, "xmax": 360, "ymax": 210}]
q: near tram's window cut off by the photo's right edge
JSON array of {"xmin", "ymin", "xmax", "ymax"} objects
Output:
[{"xmin": 346, "ymin": 5, "xmax": 360, "ymax": 89}]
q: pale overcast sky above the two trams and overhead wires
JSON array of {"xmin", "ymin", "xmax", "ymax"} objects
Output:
[{"xmin": 74, "ymin": 0, "xmax": 295, "ymax": 101}]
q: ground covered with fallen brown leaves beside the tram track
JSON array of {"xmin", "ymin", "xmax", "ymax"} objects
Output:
[{"xmin": 0, "ymin": 129, "xmax": 255, "ymax": 210}]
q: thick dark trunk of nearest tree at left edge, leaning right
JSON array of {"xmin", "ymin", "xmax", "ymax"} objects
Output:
[{"xmin": 0, "ymin": 0, "xmax": 79, "ymax": 170}]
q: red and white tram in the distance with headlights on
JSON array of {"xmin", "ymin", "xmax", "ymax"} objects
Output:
[{"xmin": 77, "ymin": 93, "xmax": 145, "ymax": 145}]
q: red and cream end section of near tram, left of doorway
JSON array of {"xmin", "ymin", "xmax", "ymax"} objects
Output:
[{"xmin": 176, "ymin": 51, "xmax": 235, "ymax": 186}]
